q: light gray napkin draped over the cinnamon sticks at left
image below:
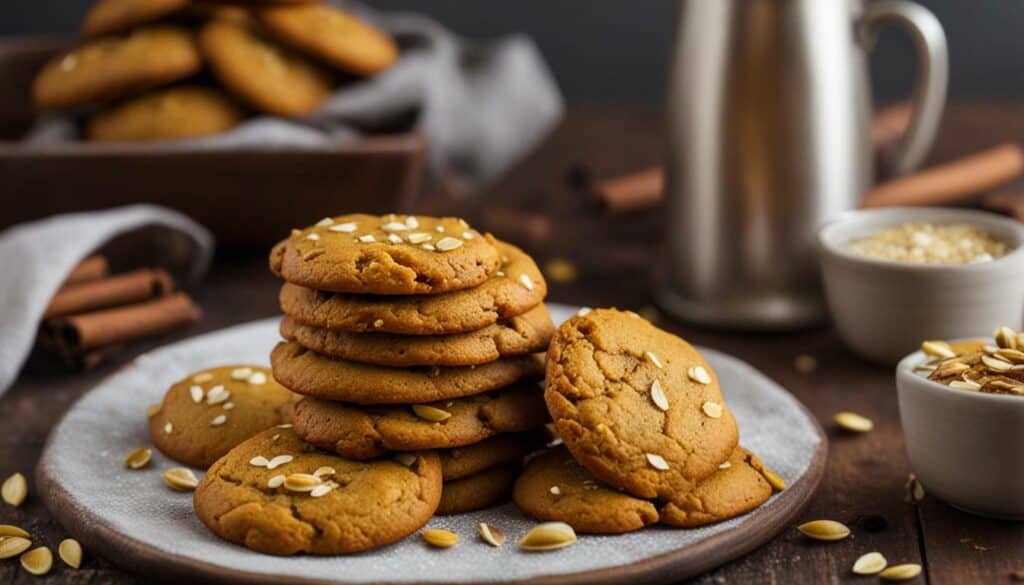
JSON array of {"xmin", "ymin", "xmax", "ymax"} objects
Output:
[{"xmin": 0, "ymin": 205, "xmax": 213, "ymax": 394}]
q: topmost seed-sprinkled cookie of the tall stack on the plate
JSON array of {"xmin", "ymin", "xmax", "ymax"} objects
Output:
[{"xmin": 270, "ymin": 213, "xmax": 501, "ymax": 295}]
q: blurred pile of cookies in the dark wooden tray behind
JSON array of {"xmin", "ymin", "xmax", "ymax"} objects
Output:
[{"xmin": 33, "ymin": 0, "xmax": 398, "ymax": 140}]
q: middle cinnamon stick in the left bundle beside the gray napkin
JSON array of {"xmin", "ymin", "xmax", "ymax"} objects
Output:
[{"xmin": 43, "ymin": 268, "xmax": 174, "ymax": 319}]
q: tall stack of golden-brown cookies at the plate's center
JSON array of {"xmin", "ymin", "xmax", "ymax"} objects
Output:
[{"xmin": 270, "ymin": 214, "xmax": 554, "ymax": 514}]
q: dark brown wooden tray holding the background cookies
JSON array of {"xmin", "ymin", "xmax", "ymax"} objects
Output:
[{"xmin": 0, "ymin": 39, "xmax": 426, "ymax": 250}]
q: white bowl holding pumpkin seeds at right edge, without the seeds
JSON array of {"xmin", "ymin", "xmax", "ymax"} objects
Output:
[{"xmin": 896, "ymin": 351, "xmax": 1024, "ymax": 520}]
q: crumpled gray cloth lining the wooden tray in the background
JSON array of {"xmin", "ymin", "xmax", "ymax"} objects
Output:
[{"xmin": 27, "ymin": 3, "xmax": 563, "ymax": 191}]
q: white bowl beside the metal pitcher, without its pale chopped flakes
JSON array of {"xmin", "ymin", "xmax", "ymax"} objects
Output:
[{"xmin": 818, "ymin": 207, "xmax": 1024, "ymax": 365}]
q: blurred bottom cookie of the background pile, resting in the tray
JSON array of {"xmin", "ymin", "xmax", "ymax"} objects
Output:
[{"xmin": 88, "ymin": 86, "xmax": 245, "ymax": 141}]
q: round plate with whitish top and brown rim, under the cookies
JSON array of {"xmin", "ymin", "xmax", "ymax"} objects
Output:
[{"xmin": 37, "ymin": 304, "xmax": 827, "ymax": 585}]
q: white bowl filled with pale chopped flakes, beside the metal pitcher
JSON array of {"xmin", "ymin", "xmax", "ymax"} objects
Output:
[{"xmin": 818, "ymin": 207, "xmax": 1024, "ymax": 365}]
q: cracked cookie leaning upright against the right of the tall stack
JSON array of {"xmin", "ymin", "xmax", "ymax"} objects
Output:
[{"xmin": 544, "ymin": 309, "xmax": 739, "ymax": 499}]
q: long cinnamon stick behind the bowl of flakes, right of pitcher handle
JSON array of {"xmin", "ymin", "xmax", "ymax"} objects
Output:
[{"xmin": 862, "ymin": 142, "xmax": 1024, "ymax": 207}]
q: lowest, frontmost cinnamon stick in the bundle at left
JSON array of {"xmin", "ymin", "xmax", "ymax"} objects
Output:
[{"xmin": 48, "ymin": 292, "xmax": 201, "ymax": 353}]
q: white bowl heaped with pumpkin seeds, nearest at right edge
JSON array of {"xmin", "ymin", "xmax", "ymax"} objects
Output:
[{"xmin": 896, "ymin": 327, "xmax": 1024, "ymax": 520}]
